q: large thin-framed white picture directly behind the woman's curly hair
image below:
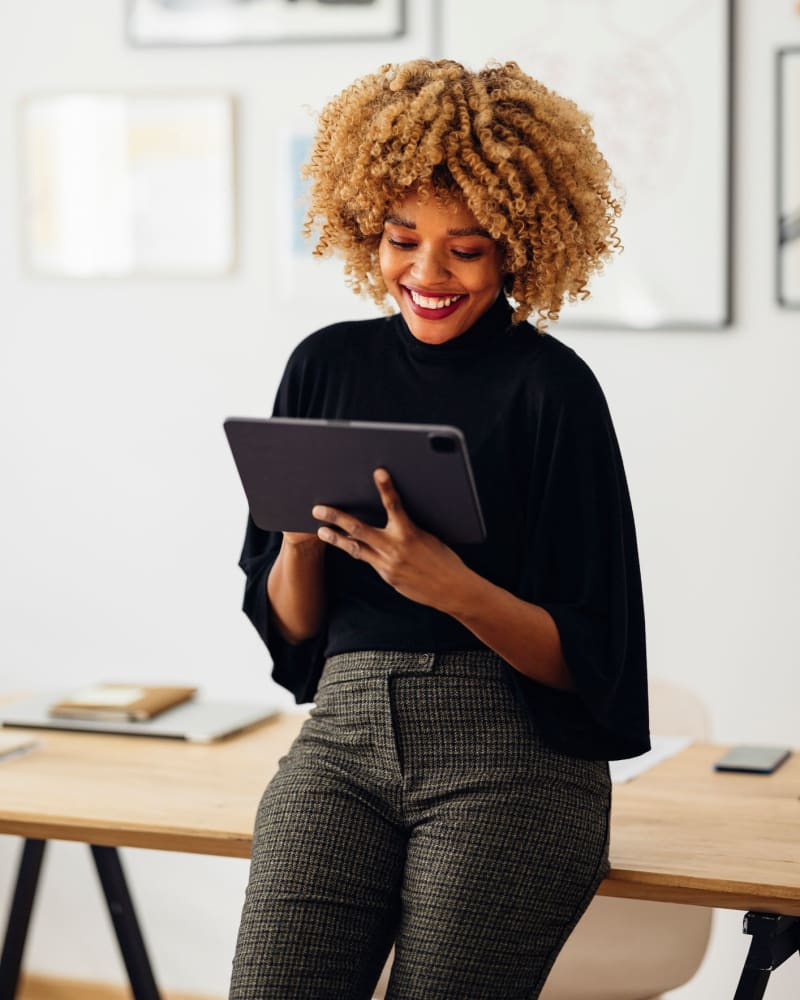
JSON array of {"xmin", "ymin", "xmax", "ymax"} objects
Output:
[{"xmin": 439, "ymin": 0, "xmax": 732, "ymax": 329}]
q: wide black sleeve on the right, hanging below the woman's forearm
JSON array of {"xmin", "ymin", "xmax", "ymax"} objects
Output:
[{"xmin": 519, "ymin": 369, "xmax": 649, "ymax": 757}]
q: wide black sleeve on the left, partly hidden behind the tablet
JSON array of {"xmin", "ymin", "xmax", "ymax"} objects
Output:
[{"xmin": 239, "ymin": 354, "xmax": 327, "ymax": 704}]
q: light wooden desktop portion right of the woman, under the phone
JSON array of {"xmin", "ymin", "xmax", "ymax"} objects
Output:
[{"xmin": 600, "ymin": 744, "xmax": 800, "ymax": 916}]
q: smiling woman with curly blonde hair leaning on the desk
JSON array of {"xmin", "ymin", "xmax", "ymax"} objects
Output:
[{"xmin": 231, "ymin": 60, "xmax": 649, "ymax": 1000}]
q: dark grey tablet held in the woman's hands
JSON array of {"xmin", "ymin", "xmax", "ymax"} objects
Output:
[{"xmin": 224, "ymin": 417, "xmax": 486, "ymax": 545}]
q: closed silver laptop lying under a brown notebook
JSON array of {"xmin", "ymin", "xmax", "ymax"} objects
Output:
[{"xmin": 0, "ymin": 692, "xmax": 280, "ymax": 743}]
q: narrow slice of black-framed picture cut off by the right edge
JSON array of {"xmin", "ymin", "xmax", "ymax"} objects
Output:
[{"xmin": 776, "ymin": 48, "xmax": 800, "ymax": 309}]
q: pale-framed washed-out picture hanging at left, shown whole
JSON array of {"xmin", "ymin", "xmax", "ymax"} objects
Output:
[{"xmin": 20, "ymin": 93, "xmax": 236, "ymax": 277}]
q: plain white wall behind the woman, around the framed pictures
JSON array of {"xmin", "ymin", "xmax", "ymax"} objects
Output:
[{"xmin": 0, "ymin": 0, "xmax": 800, "ymax": 1000}]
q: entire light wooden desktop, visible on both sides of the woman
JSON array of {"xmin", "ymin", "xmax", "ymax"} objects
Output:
[{"xmin": 0, "ymin": 713, "xmax": 800, "ymax": 915}]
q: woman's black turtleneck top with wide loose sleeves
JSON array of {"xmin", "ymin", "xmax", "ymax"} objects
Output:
[{"xmin": 240, "ymin": 296, "xmax": 649, "ymax": 759}]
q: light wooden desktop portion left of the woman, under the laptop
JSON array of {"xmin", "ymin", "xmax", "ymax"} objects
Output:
[{"xmin": 0, "ymin": 712, "xmax": 305, "ymax": 858}]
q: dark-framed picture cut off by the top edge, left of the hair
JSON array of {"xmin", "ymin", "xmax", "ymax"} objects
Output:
[{"xmin": 127, "ymin": 0, "xmax": 406, "ymax": 45}]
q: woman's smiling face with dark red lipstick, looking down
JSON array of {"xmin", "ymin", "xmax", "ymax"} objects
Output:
[{"xmin": 378, "ymin": 193, "xmax": 503, "ymax": 344}]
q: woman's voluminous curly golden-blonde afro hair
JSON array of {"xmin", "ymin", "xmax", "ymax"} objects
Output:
[{"xmin": 303, "ymin": 59, "xmax": 621, "ymax": 325}]
